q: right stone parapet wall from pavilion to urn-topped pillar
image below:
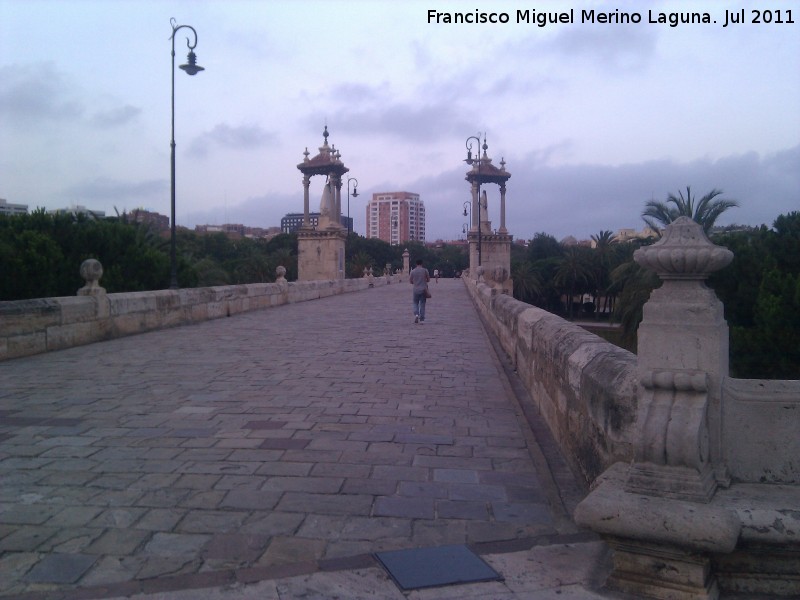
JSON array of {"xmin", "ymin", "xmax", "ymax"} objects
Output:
[{"xmin": 464, "ymin": 278, "xmax": 639, "ymax": 483}]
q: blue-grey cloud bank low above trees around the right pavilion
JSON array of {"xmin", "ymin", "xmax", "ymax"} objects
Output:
[{"xmin": 404, "ymin": 146, "xmax": 800, "ymax": 239}]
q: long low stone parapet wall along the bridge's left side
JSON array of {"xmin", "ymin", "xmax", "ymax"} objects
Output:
[{"xmin": 0, "ymin": 277, "xmax": 394, "ymax": 360}]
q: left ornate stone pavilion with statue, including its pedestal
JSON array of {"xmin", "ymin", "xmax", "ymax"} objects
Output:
[{"xmin": 297, "ymin": 125, "xmax": 349, "ymax": 281}]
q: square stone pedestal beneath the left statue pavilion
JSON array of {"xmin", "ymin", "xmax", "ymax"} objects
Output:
[{"xmin": 297, "ymin": 227, "xmax": 347, "ymax": 281}]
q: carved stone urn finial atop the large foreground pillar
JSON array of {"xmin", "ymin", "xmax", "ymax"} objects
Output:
[{"xmin": 633, "ymin": 217, "xmax": 733, "ymax": 280}]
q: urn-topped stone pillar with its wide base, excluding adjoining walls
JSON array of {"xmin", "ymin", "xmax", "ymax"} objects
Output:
[{"xmin": 575, "ymin": 217, "xmax": 742, "ymax": 600}]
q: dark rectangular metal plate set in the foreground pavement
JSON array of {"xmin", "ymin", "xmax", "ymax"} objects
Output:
[{"xmin": 375, "ymin": 545, "xmax": 503, "ymax": 590}]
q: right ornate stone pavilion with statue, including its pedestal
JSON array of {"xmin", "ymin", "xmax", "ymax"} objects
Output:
[{"xmin": 465, "ymin": 136, "xmax": 513, "ymax": 294}]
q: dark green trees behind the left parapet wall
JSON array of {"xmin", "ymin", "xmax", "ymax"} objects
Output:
[{"xmin": 0, "ymin": 210, "xmax": 467, "ymax": 300}]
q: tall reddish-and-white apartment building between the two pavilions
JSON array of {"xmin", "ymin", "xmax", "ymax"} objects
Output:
[{"xmin": 367, "ymin": 192, "xmax": 425, "ymax": 246}]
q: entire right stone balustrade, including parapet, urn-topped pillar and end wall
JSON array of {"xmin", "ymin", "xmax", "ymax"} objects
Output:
[{"xmin": 465, "ymin": 217, "xmax": 800, "ymax": 600}]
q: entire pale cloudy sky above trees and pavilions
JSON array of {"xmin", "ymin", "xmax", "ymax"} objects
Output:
[{"xmin": 0, "ymin": 0, "xmax": 800, "ymax": 240}]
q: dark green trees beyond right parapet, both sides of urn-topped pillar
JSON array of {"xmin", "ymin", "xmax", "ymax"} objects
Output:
[{"xmin": 511, "ymin": 213, "xmax": 800, "ymax": 379}]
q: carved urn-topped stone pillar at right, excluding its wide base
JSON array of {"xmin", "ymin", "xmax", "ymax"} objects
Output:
[{"xmin": 626, "ymin": 217, "xmax": 733, "ymax": 502}]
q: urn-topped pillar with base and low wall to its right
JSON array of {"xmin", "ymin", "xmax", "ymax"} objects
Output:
[{"xmin": 575, "ymin": 217, "xmax": 800, "ymax": 600}]
